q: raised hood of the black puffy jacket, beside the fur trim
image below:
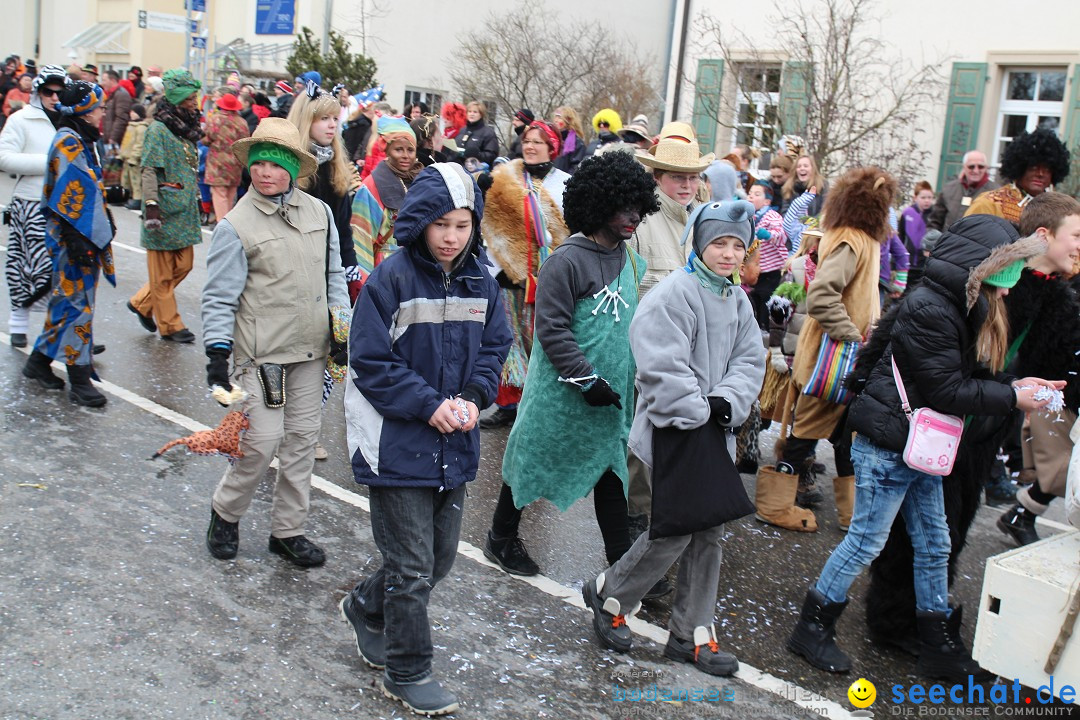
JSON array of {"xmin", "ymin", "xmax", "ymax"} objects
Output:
[{"xmin": 923, "ymin": 215, "xmax": 1020, "ymax": 308}]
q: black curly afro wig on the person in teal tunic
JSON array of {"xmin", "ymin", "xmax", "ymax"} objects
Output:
[{"xmin": 563, "ymin": 152, "xmax": 660, "ymax": 235}]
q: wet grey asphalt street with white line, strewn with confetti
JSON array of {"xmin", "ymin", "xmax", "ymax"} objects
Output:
[{"xmin": 0, "ymin": 177, "xmax": 1080, "ymax": 720}]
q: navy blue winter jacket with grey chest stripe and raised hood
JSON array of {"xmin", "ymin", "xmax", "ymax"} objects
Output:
[{"xmin": 345, "ymin": 163, "xmax": 511, "ymax": 489}]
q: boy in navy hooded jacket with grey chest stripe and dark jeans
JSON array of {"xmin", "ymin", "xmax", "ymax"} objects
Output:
[{"xmin": 341, "ymin": 163, "xmax": 511, "ymax": 715}]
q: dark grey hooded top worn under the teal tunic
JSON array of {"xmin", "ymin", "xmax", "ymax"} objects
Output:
[{"xmin": 534, "ymin": 233, "xmax": 640, "ymax": 378}]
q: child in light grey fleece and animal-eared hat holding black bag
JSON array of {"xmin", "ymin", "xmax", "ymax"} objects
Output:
[{"xmin": 582, "ymin": 201, "xmax": 766, "ymax": 676}]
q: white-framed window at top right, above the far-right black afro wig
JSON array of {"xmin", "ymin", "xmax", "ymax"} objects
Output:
[{"xmin": 991, "ymin": 67, "xmax": 1067, "ymax": 172}]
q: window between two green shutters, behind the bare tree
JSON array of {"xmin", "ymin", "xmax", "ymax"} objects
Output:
[{"xmin": 731, "ymin": 65, "xmax": 780, "ymax": 177}]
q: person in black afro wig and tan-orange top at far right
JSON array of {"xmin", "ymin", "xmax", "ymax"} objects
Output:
[{"xmin": 964, "ymin": 127, "xmax": 1069, "ymax": 227}]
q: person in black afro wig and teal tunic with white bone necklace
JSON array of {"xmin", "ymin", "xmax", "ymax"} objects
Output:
[{"xmin": 484, "ymin": 152, "xmax": 660, "ymax": 575}]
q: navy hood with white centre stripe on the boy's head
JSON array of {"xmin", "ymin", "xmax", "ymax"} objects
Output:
[{"xmin": 394, "ymin": 163, "xmax": 484, "ymax": 254}]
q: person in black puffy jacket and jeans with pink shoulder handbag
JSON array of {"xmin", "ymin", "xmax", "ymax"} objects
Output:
[{"xmin": 787, "ymin": 215, "xmax": 1065, "ymax": 681}]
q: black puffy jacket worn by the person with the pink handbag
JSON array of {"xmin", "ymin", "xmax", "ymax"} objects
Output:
[{"xmin": 848, "ymin": 215, "xmax": 1017, "ymax": 452}]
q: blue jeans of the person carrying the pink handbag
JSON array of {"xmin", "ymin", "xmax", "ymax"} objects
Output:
[{"xmin": 816, "ymin": 435, "xmax": 950, "ymax": 613}]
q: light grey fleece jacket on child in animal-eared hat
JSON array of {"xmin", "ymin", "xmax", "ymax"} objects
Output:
[{"xmin": 630, "ymin": 270, "xmax": 765, "ymax": 467}]
